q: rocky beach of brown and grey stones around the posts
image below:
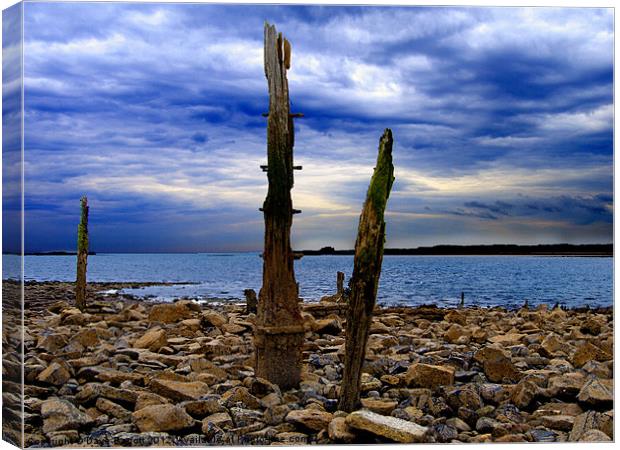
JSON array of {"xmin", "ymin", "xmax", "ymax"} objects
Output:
[{"xmin": 3, "ymin": 281, "xmax": 614, "ymax": 447}]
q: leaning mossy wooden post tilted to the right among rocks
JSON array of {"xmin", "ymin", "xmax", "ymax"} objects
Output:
[{"xmin": 338, "ymin": 129, "xmax": 394, "ymax": 412}]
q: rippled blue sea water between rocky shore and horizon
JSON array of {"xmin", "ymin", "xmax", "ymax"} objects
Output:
[{"xmin": 3, "ymin": 253, "xmax": 613, "ymax": 307}]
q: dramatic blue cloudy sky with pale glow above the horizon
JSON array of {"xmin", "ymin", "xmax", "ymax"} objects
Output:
[{"xmin": 3, "ymin": 3, "xmax": 614, "ymax": 252}]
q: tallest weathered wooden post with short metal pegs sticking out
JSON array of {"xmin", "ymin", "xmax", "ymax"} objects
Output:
[{"xmin": 254, "ymin": 23, "xmax": 304, "ymax": 389}]
